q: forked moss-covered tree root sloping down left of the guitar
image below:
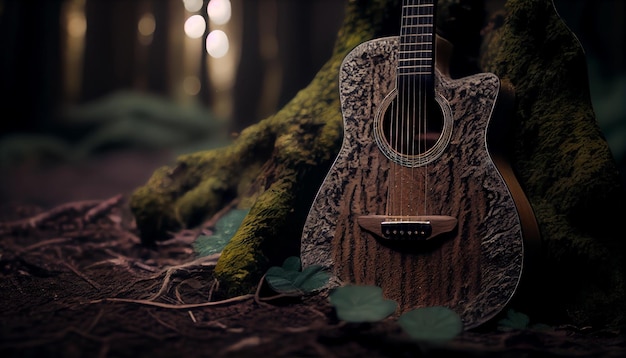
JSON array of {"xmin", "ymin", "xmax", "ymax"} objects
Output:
[{"xmin": 130, "ymin": 0, "xmax": 399, "ymax": 296}]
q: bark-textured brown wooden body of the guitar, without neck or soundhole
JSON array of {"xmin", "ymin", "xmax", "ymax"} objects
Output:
[{"xmin": 301, "ymin": 37, "xmax": 524, "ymax": 329}]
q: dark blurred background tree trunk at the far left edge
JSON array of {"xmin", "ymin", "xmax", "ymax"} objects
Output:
[{"xmin": 0, "ymin": 0, "xmax": 63, "ymax": 134}]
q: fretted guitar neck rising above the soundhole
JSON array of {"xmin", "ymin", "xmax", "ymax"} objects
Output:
[{"xmin": 397, "ymin": 0, "xmax": 437, "ymax": 90}]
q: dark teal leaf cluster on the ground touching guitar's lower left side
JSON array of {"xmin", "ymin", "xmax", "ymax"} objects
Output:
[{"xmin": 265, "ymin": 256, "xmax": 330, "ymax": 296}]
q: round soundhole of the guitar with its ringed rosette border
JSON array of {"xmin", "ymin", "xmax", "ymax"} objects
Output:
[{"xmin": 374, "ymin": 90, "xmax": 452, "ymax": 167}]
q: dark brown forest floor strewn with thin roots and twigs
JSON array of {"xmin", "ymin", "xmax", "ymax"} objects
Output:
[{"xmin": 0, "ymin": 150, "xmax": 626, "ymax": 357}]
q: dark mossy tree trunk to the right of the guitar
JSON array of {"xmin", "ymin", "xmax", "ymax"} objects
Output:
[{"xmin": 481, "ymin": 0, "xmax": 625, "ymax": 325}]
